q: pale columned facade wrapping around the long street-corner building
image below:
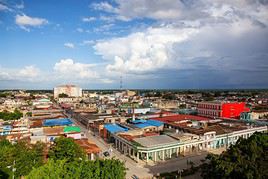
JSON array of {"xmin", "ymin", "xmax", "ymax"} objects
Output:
[{"xmin": 113, "ymin": 126, "xmax": 267, "ymax": 163}]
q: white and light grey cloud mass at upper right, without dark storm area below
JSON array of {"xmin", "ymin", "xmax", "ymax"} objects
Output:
[{"xmin": 93, "ymin": 0, "xmax": 268, "ymax": 73}]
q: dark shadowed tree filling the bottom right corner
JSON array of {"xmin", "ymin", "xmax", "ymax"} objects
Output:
[{"xmin": 202, "ymin": 133, "xmax": 268, "ymax": 179}]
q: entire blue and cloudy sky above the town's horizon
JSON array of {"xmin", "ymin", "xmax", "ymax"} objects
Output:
[{"xmin": 0, "ymin": 0, "xmax": 268, "ymax": 89}]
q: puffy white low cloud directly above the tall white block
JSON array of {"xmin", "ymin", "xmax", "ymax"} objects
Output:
[{"xmin": 53, "ymin": 59, "xmax": 98, "ymax": 80}]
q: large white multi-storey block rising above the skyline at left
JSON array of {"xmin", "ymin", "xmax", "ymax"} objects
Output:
[{"xmin": 54, "ymin": 85, "xmax": 82, "ymax": 98}]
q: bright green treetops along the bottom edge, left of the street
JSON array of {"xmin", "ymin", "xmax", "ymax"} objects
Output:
[{"xmin": 26, "ymin": 159, "xmax": 126, "ymax": 179}]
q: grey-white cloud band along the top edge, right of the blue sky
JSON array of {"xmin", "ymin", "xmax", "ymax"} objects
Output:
[{"xmin": 93, "ymin": 0, "xmax": 268, "ymax": 24}]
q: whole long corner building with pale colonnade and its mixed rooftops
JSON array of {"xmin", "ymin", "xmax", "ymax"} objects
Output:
[{"xmin": 109, "ymin": 120, "xmax": 267, "ymax": 163}]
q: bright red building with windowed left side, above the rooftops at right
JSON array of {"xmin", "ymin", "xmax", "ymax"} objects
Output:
[{"xmin": 197, "ymin": 102, "xmax": 249, "ymax": 119}]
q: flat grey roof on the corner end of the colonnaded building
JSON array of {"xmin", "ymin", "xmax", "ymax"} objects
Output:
[{"xmin": 134, "ymin": 135, "xmax": 179, "ymax": 147}]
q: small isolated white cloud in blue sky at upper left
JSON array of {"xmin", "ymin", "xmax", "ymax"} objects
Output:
[{"xmin": 15, "ymin": 14, "xmax": 48, "ymax": 31}]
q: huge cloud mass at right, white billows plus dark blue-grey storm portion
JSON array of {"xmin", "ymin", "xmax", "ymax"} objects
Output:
[{"xmin": 91, "ymin": 0, "xmax": 268, "ymax": 87}]
